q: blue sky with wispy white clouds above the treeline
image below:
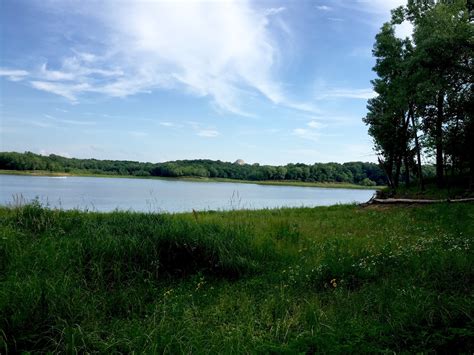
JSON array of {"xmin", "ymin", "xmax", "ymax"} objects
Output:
[{"xmin": 0, "ymin": 0, "xmax": 411, "ymax": 165}]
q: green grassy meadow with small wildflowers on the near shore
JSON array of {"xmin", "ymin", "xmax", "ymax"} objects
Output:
[{"xmin": 0, "ymin": 203, "xmax": 474, "ymax": 354}]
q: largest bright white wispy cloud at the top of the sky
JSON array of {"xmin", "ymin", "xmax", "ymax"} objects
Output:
[{"xmin": 8, "ymin": 0, "xmax": 316, "ymax": 115}]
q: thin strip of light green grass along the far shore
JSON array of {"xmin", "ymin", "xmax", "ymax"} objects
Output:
[{"xmin": 0, "ymin": 169, "xmax": 384, "ymax": 190}]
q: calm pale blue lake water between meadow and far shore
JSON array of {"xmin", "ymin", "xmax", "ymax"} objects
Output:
[{"xmin": 0, "ymin": 175, "xmax": 374, "ymax": 212}]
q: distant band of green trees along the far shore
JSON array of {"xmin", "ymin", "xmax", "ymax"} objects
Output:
[{"xmin": 0, "ymin": 152, "xmax": 396, "ymax": 186}]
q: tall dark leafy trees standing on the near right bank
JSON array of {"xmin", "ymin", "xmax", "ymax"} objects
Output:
[{"xmin": 363, "ymin": 0, "xmax": 474, "ymax": 189}]
